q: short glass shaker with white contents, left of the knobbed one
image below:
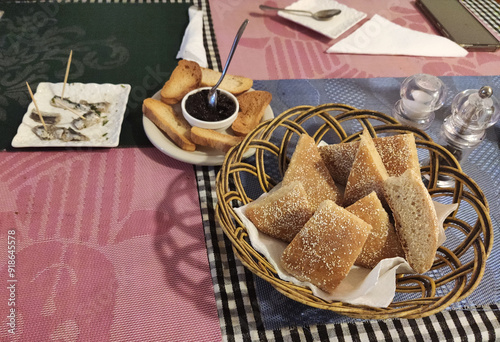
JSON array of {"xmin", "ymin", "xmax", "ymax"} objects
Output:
[{"xmin": 393, "ymin": 74, "xmax": 446, "ymax": 130}]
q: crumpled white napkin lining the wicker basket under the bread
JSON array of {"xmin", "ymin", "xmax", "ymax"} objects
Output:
[{"xmin": 234, "ymin": 193, "xmax": 457, "ymax": 307}]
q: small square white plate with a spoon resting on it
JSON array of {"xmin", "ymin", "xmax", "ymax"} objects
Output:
[{"xmin": 278, "ymin": 0, "xmax": 366, "ymax": 39}]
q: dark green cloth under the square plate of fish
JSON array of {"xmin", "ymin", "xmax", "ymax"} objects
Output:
[{"xmin": 0, "ymin": 3, "xmax": 190, "ymax": 150}]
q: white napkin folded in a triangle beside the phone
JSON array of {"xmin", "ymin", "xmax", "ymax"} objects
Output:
[{"xmin": 326, "ymin": 14, "xmax": 467, "ymax": 57}]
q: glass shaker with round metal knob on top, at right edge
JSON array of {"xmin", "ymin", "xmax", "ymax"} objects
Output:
[{"xmin": 439, "ymin": 86, "xmax": 500, "ymax": 163}]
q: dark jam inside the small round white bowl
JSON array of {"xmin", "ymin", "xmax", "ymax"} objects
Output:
[{"xmin": 185, "ymin": 89, "xmax": 236, "ymax": 121}]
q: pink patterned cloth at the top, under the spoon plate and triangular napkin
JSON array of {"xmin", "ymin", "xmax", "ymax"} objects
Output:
[{"xmin": 210, "ymin": 0, "xmax": 500, "ymax": 80}]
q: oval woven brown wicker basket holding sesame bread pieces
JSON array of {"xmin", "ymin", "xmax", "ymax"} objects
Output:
[{"xmin": 216, "ymin": 104, "xmax": 493, "ymax": 319}]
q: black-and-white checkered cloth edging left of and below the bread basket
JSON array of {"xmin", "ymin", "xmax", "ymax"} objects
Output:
[{"xmin": 195, "ymin": 8, "xmax": 500, "ymax": 341}]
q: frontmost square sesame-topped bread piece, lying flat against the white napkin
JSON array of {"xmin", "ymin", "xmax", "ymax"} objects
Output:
[{"xmin": 281, "ymin": 200, "xmax": 372, "ymax": 292}]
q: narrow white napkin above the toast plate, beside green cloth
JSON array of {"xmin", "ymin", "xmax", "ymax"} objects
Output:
[{"xmin": 177, "ymin": 6, "xmax": 208, "ymax": 68}]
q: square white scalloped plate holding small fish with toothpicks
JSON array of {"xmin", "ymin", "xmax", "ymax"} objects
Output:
[{"xmin": 12, "ymin": 82, "xmax": 131, "ymax": 147}]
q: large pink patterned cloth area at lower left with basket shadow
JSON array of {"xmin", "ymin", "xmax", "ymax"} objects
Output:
[{"xmin": 0, "ymin": 148, "xmax": 221, "ymax": 341}]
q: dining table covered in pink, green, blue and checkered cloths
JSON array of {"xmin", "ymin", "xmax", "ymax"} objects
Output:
[{"xmin": 0, "ymin": 0, "xmax": 500, "ymax": 341}]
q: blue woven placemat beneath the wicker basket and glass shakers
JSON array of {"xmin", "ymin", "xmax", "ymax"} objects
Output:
[{"xmin": 254, "ymin": 76, "xmax": 500, "ymax": 329}]
